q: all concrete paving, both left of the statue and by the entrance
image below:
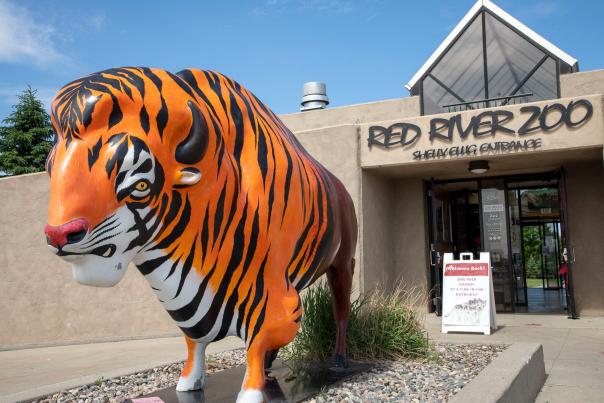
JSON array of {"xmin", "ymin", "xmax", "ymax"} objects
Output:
[{"xmin": 0, "ymin": 314, "xmax": 604, "ymax": 402}]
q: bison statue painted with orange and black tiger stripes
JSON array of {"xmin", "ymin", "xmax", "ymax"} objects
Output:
[{"xmin": 45, "ymin": 67, "xmax": 357, "ymax": 402}]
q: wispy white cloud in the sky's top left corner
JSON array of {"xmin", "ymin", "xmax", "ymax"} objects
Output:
[{"xmin": 0, "ymin": 0, "xmax": 65, "ymax": 67}]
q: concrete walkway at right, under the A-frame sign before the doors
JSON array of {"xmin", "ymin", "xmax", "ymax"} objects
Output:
[{"xmin": 425, "ymin": 314, "xmax": 604, "ymax": 403}]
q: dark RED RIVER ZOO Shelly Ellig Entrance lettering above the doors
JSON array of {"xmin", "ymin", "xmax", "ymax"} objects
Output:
[{"xmin": 367, "ymin": 99, "xmax": 594, "ymax": 160}]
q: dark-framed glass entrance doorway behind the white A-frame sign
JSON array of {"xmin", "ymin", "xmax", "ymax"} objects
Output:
[{"xmin": 428, "ymin": 173, "xmax": 569, "ymax": 313}]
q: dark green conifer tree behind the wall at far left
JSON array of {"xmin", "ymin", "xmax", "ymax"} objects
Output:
[{"xmin": 0, "ymin": 85, "xmax": 54, "ymax": 176}]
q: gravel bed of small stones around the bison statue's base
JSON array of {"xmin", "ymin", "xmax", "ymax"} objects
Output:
[{"xmin": 34, "ymin": 344, "xmax": 505, "ymax": 403}]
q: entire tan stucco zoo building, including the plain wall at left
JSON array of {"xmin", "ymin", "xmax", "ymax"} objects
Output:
[{"xmin": 0, "ymin": 0, "xmax": 604, "ymax": 348}]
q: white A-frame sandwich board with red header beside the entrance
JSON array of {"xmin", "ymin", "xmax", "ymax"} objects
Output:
[{"xmin": 442, "ymin": 252, "xmax": 497, "ymax": 334}]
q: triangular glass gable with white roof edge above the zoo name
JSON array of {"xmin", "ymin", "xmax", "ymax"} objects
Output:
[{"xmin": 407, "ymin": 5, "xmax": 578, "ymax": 115}]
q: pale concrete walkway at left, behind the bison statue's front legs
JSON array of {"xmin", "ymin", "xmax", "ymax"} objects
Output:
[{"xmin": 0, "ymin": 337, "xmax": 244, "ymax": 403}]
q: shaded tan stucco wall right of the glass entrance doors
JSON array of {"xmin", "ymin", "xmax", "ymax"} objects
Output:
[{"xmin": 565, "ymin": 160, "xmax": 604, "ymax": 316}]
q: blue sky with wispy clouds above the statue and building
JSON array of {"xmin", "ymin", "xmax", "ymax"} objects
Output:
[{"xmin": 0, "ymin": 0, "xmax": 604, "ymax": 119}]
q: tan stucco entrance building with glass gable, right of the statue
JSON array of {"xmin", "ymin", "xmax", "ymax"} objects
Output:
[{"xmin": 282, "ymin": 0, "xmax": 604, "ymax": 317}]
